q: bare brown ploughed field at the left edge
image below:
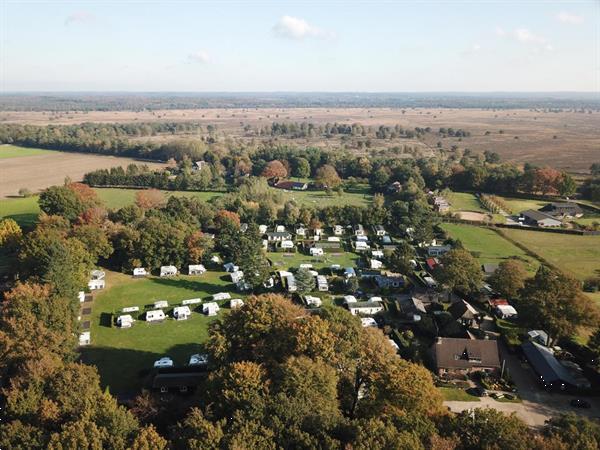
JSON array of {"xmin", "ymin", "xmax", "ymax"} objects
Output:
[{"xmin": 0, "ymin": 152, "xmax": 160, "ymax": 198}]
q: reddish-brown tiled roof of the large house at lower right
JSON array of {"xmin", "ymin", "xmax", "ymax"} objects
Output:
[{"xmin": 431, "ymin": 338, "xmax": 500, "ymax": 369}]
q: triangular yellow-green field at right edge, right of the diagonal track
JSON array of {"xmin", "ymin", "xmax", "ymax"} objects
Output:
[{"xmin": 502, "ymin": 229, "xmax": 600, "ymax": 280}]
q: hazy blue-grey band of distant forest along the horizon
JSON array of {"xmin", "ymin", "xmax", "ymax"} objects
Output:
[{"xmin": 0, "ymin": 92, "xmax": 600, "ymax": 112}]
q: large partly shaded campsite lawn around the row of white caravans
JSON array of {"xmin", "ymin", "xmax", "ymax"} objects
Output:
[{"xmin": 82, "ymin": 272, "xmax": 243, "ymax": 392}]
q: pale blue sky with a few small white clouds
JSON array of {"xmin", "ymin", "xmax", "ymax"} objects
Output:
[{"xmin": 0, "ymin": 0, "xmax": 600, "ymax": 92}]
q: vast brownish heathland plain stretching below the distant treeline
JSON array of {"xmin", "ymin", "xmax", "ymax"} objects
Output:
[{"xmin": 0, "ymin": 108, "xmax": 600, "ymax": 173}]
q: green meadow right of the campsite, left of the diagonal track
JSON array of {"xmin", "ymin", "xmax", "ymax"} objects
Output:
[{"xmin": 442, "ymin": 223, "xmax": 547, "ymax": 273}]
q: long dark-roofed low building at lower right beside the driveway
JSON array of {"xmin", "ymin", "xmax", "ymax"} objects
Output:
[{"xmin": 521, "ymin": 341, "xmax": 591, "ymax": 391}]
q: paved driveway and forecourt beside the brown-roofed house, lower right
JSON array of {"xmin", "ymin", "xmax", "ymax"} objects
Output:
[{"xmin": 444, "ymin": 346, "xmax": 600, "ymax": 427}]
